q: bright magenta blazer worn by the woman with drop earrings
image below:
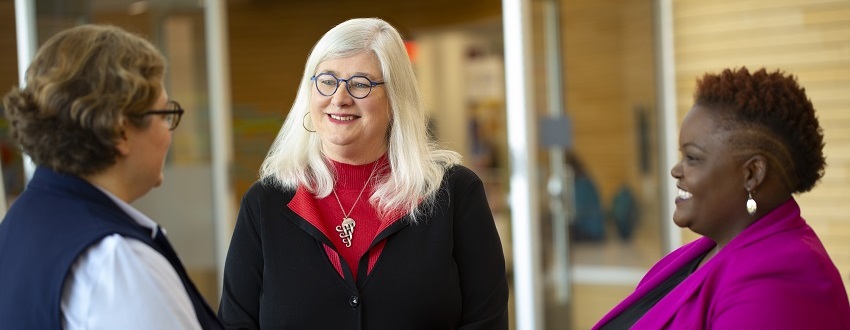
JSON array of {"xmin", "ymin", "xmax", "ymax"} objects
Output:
[{"xmin": 593, "ymin": 198, "xmax": 850, "ymax": 329}]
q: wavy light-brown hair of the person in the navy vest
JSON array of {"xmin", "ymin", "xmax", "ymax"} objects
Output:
[{"xmin": 3, "ymin": 25, "xmax": 165, "ymax": 176}]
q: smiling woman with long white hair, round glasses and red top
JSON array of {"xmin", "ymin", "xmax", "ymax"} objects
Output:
[{"xmin": 219, "ymin": 18, "xmax": 508, "ymax": 329}]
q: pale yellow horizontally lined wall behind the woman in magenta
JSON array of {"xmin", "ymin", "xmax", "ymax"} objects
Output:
[{"xmin": 673, "ymin": 0, "xmax": 850, "ymax": 294}]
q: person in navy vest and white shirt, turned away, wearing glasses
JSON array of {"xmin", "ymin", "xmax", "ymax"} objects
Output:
[{"xmin": 0, "ymin": 25, "xmax": 221, "ymax": 329}]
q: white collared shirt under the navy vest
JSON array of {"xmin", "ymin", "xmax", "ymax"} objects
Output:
[{"xmin": 62, "ymin": 187, "xmax": 201, "ymax": 329}]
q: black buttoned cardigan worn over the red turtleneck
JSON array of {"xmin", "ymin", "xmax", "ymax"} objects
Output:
[{"xmin": 219, "ymin": 166, "xmax": 508, "ymax": 330}]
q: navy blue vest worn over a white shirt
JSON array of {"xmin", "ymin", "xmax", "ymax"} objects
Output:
[{"xmin": 0, "ymin": 167, "xmax": 221, "ymax": 329}]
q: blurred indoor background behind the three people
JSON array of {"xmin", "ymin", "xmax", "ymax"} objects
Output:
[{"xmin": 0, "ymin": 0, "xmax": 850, "ymax": 330}]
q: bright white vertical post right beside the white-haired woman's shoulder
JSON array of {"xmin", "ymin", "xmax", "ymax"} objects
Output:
[{"xmin": 502, "ymin": 0, "xmax": 544, "ymax": 330}]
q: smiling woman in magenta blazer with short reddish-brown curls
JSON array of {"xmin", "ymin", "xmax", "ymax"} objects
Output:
[{"xmin": 594, "ymin": 68, "xmax": 850, "ymax": 329}]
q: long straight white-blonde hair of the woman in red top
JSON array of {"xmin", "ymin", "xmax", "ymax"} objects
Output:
[{"xmin": 260, "ymin": 18, "xmax": 460, "ymax": 222}]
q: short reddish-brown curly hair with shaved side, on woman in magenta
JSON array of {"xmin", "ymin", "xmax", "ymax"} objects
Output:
[{"xmin": 694, "ymin": 67, "xmax": 826, "ymax": 193}]
